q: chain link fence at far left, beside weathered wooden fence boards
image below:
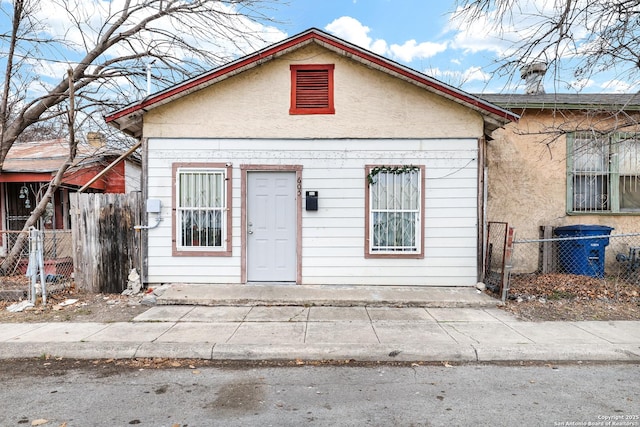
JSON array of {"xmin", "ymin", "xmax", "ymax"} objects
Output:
[{"xmin": 0, "ymin": 230, "xmax": 73, "ymax": 300}]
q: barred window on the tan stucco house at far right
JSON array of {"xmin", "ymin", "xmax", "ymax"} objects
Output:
[{"xmin": 567, "ymin": 132, "xmax": 640, "ymax": 213}]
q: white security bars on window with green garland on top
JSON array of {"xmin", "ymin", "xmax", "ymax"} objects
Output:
[{"xmin": 369, "ymin": 170, "xmax": 421, "ymax": 253}]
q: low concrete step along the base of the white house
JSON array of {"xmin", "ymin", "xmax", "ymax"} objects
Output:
[{"xmin": 157, "ymin": 283, "xmax": 499, "ymax": 308}]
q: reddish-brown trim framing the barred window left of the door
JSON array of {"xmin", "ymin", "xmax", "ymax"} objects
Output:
[{"xmin": 171, "ymin": 163, "xmax": 233, "ymax": 257}]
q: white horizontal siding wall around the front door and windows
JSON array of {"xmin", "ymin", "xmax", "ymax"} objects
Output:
[{"xmin": 148, "ymin": 138, "xmax": 478, "ymax": 286}]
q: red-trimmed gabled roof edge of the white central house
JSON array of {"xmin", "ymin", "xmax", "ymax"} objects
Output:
[{"xmin": 105, "ymin": 28, "xmax": 518, "ymax": 137}]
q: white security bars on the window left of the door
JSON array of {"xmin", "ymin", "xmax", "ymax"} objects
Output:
[{"xmin": 176, "ymin": 169, "xmax": 226, "ymax": 249}]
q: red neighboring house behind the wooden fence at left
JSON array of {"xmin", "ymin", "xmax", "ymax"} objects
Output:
[{"xmin": 0, "ymin": 139, "xmax": 141, "ymax": 254}]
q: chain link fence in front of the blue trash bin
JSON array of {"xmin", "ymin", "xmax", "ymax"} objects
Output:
[{"xmin": 485, "ymin": 223, "xmax": 640, "ymax": 301}]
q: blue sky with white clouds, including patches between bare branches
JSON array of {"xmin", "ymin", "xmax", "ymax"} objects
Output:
[{"xmin": 0, "ymin": 0, "xmax": 639, "ymax": 93}]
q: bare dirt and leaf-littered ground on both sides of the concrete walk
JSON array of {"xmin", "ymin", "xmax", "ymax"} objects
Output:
[{"xmin": 0, "ymin": 274, "xmax": 640, "ymax": 322}]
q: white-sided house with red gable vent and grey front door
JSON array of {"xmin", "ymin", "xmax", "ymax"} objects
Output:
[{"xmin": 106, "ymin": 29, "xmax": 517, "ymax": 286}]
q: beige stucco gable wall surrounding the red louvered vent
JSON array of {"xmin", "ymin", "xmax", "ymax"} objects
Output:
[{"xmin": 144, "ymin": 44, "xmax": 483, "ymax": 138}]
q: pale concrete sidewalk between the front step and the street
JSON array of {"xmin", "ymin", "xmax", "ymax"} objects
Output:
[{"xmin": 0, "ymin": 300, "xmax": 640, "ymax": 362}]
